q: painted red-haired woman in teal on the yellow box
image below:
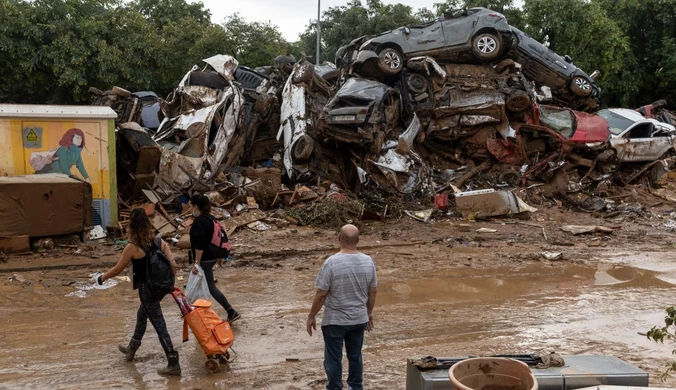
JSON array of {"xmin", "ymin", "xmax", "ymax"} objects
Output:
[{"xmin": 30, "ymin": 128, "xmax": 89, "ymax": 182}]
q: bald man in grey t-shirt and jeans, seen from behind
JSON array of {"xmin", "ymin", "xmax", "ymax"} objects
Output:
[{"xmin": 307, "ymin": 225, "xmax": 378, "ymax": 390}]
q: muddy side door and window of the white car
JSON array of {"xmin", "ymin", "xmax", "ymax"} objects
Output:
[{"xmin": 611, "ymin": 122, "xmax": 674, "ymax": 162}]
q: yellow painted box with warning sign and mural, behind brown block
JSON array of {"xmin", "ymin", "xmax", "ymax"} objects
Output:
[{"xmin": 0, "ymin": 104, "xmax": 117, "ymax": 226}]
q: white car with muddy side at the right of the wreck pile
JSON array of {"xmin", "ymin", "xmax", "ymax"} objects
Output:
[{"xmin": 597, "ymin": 108, "xmax": 676, "ymax": 162}]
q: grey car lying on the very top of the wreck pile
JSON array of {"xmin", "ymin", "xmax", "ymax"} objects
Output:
[{"xmin": 348, "ymin": 7, "xmax": 512, "ymax": 75}]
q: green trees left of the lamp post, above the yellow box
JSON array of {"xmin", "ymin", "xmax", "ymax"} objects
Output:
[{"xmin": 0, "ymin": 0, "xmax": 290, "ymax": 104}]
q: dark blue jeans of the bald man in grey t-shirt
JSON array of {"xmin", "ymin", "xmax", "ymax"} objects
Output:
[{"xmin": 322, "ymin": 324, "xmax": 366, "ymax": 390}]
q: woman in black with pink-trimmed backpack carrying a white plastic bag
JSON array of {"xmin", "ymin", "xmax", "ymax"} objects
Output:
[{"xmin": 190, "ymin": 194, "xmax": 241, "ymax": 324}]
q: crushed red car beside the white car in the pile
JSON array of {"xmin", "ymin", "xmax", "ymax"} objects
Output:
[{"xmin": 525, "ymin": 105, "xmax": 610, "ymax": 144}]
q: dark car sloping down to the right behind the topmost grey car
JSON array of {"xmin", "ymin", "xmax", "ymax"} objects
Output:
[{"xmin": 511, "ymin": 27, "xmax": 601, "ymax": 111}]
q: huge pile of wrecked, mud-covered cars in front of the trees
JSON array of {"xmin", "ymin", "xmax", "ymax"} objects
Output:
[{"xmin": 93, "ymin": 7, "xmax": 676, "ymax": 213}]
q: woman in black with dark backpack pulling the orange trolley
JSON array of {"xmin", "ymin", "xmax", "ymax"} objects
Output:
[{"xmin": 96, "ymin": 207, "xmax": 181, "ymax": 375}]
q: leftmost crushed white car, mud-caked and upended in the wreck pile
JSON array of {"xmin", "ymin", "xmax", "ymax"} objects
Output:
[{"xmin": 153, "ymin": 55, "xmax": 243, "ymax": 189}]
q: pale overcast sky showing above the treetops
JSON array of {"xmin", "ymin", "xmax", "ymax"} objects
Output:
[{"xmin": 197, "ymin": 0, "xmax": 442, "ymax": 42}]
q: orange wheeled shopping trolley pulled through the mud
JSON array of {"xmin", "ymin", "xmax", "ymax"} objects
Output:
[{"xmin": 171, "ymin": 287, "xmax": 235, "ymax": 372}]
